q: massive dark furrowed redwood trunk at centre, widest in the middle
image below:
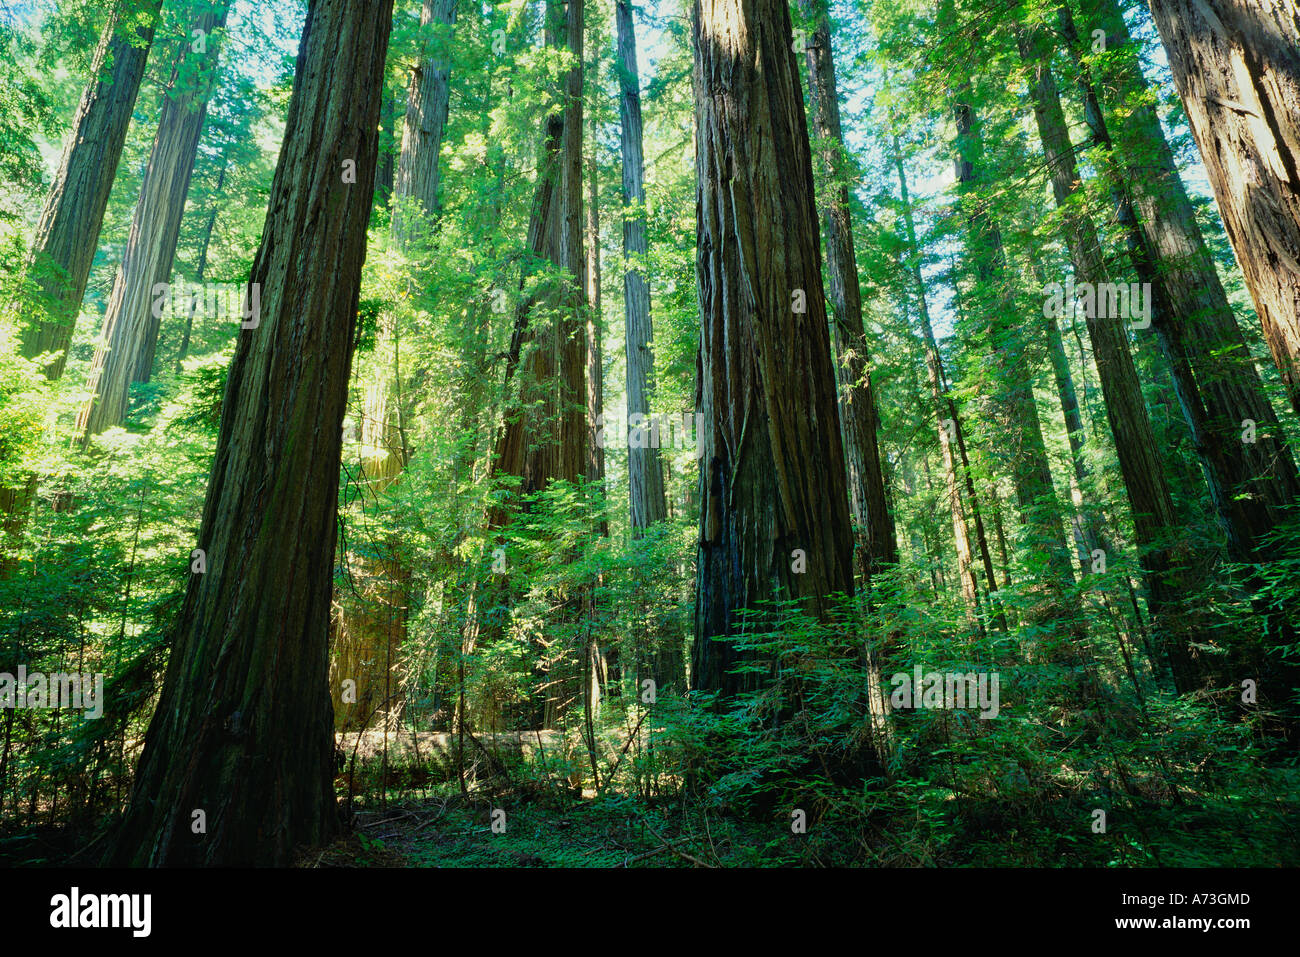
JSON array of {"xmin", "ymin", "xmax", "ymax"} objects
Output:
[{"xmin": 692, "ymin": 0, "xmax": 854, "ymax": 696}]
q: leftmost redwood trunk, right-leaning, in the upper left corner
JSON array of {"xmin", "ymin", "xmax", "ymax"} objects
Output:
[{"xmin": 20, "ymin": 0, "xmax": 163, "ymax": 378}]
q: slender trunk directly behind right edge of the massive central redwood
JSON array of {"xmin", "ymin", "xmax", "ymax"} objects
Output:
[{"xmin": 800, "ymin": 0, "xmax": 898, "ymax": 585}]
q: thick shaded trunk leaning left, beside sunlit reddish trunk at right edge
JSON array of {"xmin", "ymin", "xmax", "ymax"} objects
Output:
[{"xmin": 1058, "ymin": 0, "xmax": 1300, "ymax": 741}]
